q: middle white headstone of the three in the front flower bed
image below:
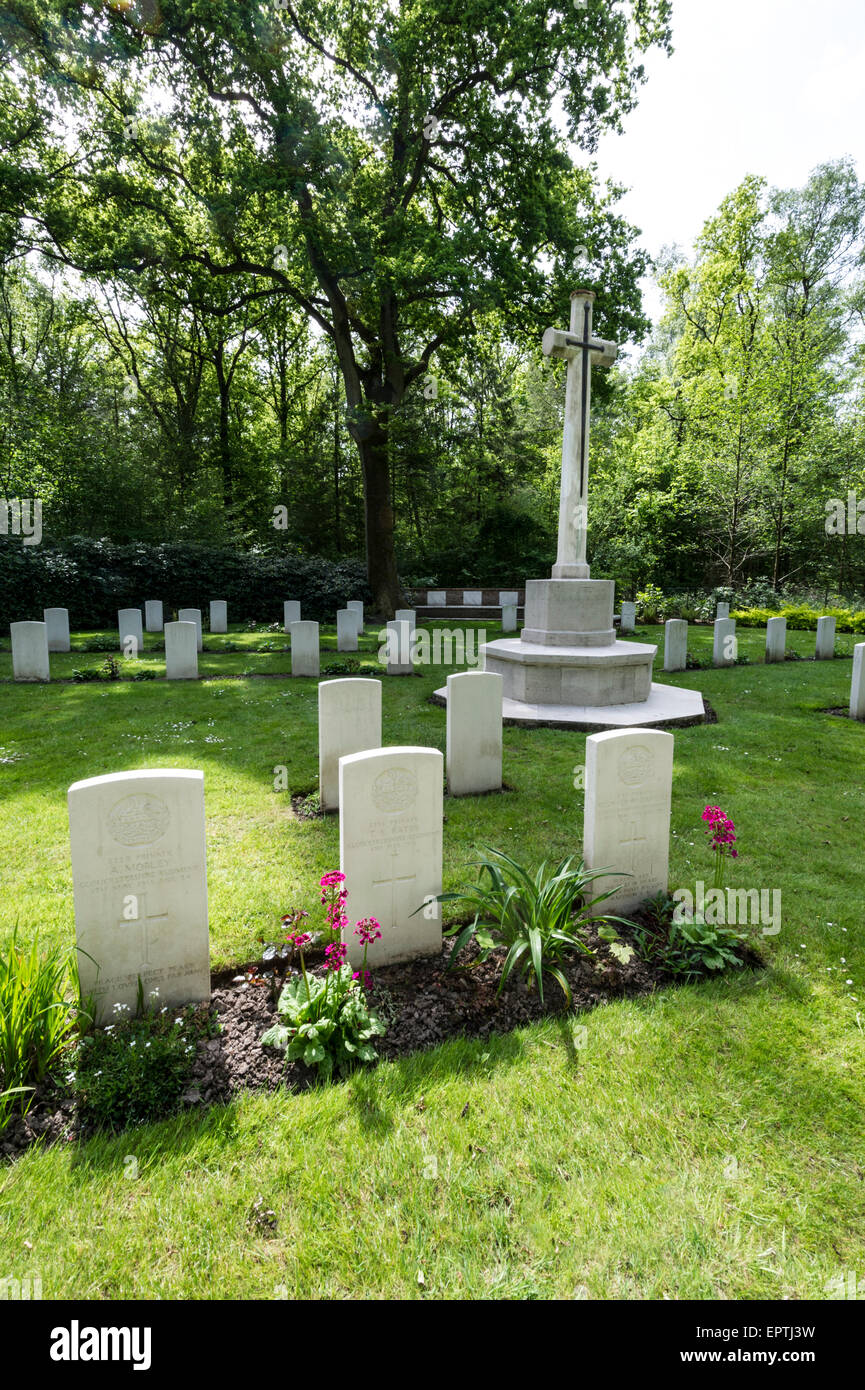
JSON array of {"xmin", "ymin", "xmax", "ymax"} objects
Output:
[{"xmin": 339, "ymin": 748, "xmax": 444, "ymax": 970}]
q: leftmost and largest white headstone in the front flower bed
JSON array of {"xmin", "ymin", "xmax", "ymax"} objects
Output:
[{"xmin": 68, "ymin": 769, "xmax": 210, "ymax": 1022}]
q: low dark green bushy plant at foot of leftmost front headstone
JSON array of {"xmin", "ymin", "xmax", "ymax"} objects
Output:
[{"xmin": 72, "ymin": 1006, "xmax": 214, "ymax": 1130}]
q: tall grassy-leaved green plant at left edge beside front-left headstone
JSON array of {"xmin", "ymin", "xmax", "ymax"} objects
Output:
[{"xmin": 0, "ymin": 929, "xmax": 82, "ymax": 1133}]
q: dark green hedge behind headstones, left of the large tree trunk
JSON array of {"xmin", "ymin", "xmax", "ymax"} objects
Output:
[{"xmin": 0, "ymin": 537, "xmax": 371, "ymax": 637}]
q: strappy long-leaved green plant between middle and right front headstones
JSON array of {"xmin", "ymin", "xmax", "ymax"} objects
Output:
[{"xmin": 439, "ymin": 849, "xmax": 636, "ymax": 1006}]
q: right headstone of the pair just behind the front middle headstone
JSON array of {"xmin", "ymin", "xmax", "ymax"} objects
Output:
[{"xmin": 448, "ymin": 671, "xmax": 503, "ymax": 796}]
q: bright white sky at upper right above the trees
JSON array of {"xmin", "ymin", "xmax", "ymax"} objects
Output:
[{"xmin": 598, "ymin": 0, "xmax": 865, "ymax": 328}]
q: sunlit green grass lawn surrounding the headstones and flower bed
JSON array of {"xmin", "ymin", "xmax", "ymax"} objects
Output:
[{"xmin": 0, "ymin": 623, "xmax": 865, "ymax": 1298}]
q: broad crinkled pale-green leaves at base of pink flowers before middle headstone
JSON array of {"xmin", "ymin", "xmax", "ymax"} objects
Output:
[{"xmin": 261, "ymin": 965, "xmax": 385, "ymax": 1081}]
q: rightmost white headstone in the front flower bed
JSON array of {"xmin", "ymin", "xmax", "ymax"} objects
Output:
[{"xmin": 583, "ymin": 728, "xmax": 673, "ymax": 915}]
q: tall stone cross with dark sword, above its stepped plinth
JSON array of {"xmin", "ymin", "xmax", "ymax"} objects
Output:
[{"xmin": 541, "ymin": 289, "xmax": 619, "ymax": 580}]
